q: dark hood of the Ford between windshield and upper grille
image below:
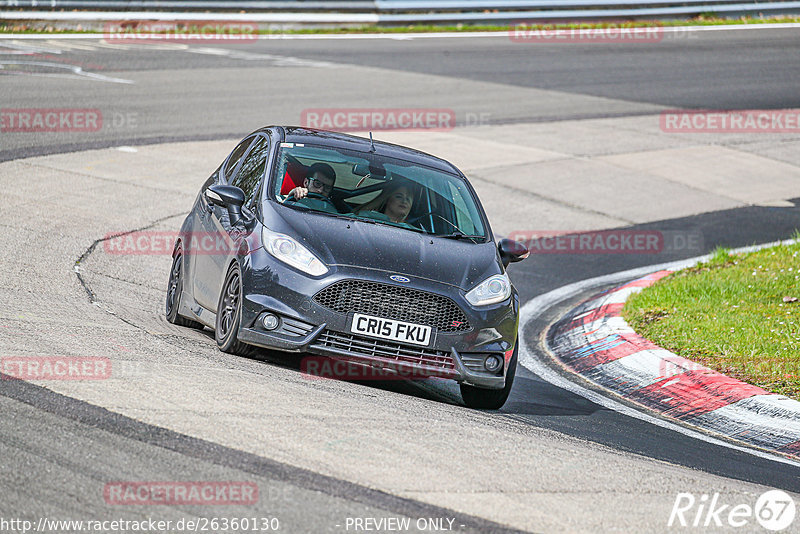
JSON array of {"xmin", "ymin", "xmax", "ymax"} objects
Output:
[{"xmin": 265, "ymin": 206, "xmax": 502, "ymax": 291}]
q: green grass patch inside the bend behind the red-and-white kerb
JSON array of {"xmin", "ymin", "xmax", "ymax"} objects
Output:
[{"xmin": 623, "ymin": 239, "xmax": 800, "ymax": 400}]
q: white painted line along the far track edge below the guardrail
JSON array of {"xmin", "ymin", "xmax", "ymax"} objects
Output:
[{"xmin": 0, "ymin": 22, "xmax": 800, "ymax": 40}]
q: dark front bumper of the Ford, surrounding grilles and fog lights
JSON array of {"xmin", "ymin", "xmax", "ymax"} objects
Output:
[{"xmin": 239, "ymin": 249, "xmax": 519, "ymax": 389}]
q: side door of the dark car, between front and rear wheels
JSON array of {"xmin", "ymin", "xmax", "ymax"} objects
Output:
[{"xmin": 192, "ymin": 135, "xmax": 259, "ymax": 311}]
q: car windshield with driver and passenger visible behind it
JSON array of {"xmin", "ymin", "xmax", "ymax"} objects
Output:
[{"xmin": 272, "ymin": 143, "xmax": 486, "ymax": 239}]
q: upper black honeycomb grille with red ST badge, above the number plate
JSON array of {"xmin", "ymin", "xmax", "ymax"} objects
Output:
[{"xmin": 314, "ymin": 280, "xmax": 472, "ymax": 332}]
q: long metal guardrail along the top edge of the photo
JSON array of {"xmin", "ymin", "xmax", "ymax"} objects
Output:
[{"xmin": 0, "ymin": 0, "xmax": 800, "ymax": 24}]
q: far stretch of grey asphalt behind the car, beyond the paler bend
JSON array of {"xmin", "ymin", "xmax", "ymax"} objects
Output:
[{"xmin": 0, "ymin": 29, "xmax": 800, "ymax": 161}]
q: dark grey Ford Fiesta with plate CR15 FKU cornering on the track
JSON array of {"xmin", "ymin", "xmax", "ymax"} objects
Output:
[{"xmin": 166, "ymin": 126, "xmax": 528, "ymax": 409}]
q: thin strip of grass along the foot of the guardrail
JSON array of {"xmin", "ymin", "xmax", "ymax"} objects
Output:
[{"xmin": 0, "ymin": 14, "xmax": 800, "ymax": 35}]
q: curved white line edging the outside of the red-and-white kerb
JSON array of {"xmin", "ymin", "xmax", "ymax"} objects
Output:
[{"xmin": 519, "ymin": 239, "xmax": 800, "ymax": 467}]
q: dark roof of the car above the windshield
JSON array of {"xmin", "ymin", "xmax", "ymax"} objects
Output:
[{"xmin": 279, "ymin": 126, "xmax": 463, "ymax": 176}]
